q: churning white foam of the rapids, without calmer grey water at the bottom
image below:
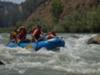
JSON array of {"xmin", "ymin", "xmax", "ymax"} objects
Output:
[{"xmin": 0, "ymin": 34, "xmax": 100, "ymax": 74}]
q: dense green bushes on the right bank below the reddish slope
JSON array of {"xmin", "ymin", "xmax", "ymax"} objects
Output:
[{"xmin": 62, "ymin": 6, "xmax": 100, "ymax": 32}]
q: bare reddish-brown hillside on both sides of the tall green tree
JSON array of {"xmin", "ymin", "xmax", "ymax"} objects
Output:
[{"xmin": 25, "ymin": 0, "xmax": 100, "ymax": 23}]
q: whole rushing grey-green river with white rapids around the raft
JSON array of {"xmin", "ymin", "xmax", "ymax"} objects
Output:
[{"xmin": 0, "ymin": 33, "xmax": 100, "ymax": 75}]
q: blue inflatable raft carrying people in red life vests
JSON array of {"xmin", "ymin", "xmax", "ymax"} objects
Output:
[{"xmin": 7, "ymin": 37, "xmax": 65, "ymax": 50}]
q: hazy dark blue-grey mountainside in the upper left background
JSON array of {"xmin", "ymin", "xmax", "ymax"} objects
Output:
[{"xmin": 0, "ymin": 0, "xmax": 46, "ymax": 27}]
